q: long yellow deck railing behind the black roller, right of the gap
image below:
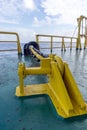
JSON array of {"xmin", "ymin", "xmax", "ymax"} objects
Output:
[{"xmin": 36, "ymin": 34, "xmax": 77, "ymax": 53}]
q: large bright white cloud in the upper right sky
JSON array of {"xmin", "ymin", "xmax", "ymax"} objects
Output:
[{"xmin": 41, "ymin": 0, "xmax": 87, "ymax": 24}]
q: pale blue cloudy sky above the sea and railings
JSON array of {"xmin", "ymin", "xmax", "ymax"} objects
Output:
[{"xmin": 0, "ymin": 0, "xmax": 87, "ymax": 42}]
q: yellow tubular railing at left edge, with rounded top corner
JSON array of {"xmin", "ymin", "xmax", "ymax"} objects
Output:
[{"xmin": 0, "ymin": 31, "xmax": 22, "ymax": 54}]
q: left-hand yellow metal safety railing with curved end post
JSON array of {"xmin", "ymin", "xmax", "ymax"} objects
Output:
[{"xmin": 0, "ymin": 31, "xmax": 22, "ymax": 54}]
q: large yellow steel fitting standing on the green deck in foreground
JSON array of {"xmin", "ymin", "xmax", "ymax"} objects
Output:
[{"xmin": 15, "ymin": 48, "xmax": 87, "ymax": 118}]
